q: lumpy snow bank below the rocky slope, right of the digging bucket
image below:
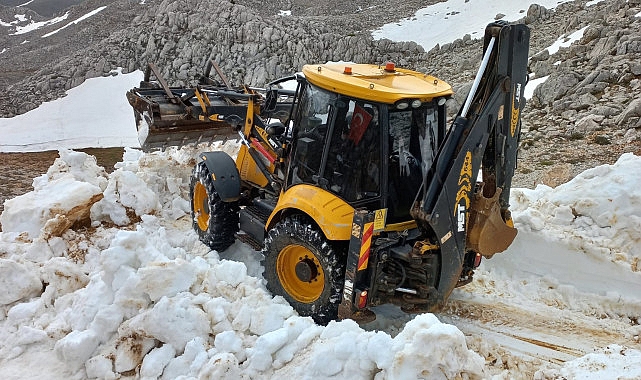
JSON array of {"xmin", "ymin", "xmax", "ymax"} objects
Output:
[{"xmin": 511, "ymin": 153, "xmax": 641, "ymax": 272}]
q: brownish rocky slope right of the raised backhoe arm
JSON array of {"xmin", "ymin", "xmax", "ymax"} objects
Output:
[{"xmin": 520, "ymin": 0, "xmax": 641, "ymax": 186}]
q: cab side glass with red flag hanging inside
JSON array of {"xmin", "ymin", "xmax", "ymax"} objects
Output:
[{"xmin": 288, "ymin": 83, "xmax": 382, "ymax": 203}]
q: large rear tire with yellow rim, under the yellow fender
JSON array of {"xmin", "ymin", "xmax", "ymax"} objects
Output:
[{"xmin": 263, "ymin": 216, "xmax": 346, "ymax": 325}]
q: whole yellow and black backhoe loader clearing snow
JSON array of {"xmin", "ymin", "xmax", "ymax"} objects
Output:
[{"xmin": 127, "ymin": 22, "xmax": 529, "ymax": 324}]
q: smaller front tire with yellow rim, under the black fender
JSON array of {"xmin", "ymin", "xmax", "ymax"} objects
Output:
[{"xmin": 189, "ymin": 162, "xmax": 240, "ymax": 252}]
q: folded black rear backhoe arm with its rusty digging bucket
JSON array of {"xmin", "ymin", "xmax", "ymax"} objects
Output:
[{"xmin": 411, "ymin": 22, "xmax": 529, "ymax": 300}]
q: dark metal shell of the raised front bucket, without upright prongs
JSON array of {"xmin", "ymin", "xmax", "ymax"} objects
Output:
[{"xmin": 127, "ymin": 88, "xmax": 238, "ymax": 151}]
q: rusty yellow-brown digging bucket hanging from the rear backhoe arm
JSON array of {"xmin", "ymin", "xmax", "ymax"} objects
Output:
[{"xmin": 467, "ymin": 186, "xmax": 517, "ymax": 259}]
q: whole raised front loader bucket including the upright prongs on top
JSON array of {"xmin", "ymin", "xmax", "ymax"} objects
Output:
[{"xmin": 127, "ymin": 64, "xmax": 245, "ymax": 151}]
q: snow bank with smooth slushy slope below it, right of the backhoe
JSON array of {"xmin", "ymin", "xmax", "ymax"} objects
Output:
[{"xmin": 464, "ymin": 154, "xmax": 641, "ymax": 326}]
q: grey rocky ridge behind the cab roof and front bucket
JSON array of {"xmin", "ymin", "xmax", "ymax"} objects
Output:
[{"xmin": 0, "ymin": 0, "xmax": 440, "ymax": 117}]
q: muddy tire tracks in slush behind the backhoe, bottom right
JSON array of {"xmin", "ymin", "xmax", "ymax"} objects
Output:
[{"xmin": 437, "ymin": 300, "xmax": 641, "ymax": 379}]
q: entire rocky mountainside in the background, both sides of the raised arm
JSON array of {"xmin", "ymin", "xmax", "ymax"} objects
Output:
[{"xmin": 0, "ymin": 0, "xmax": 641, "ymax": 186}]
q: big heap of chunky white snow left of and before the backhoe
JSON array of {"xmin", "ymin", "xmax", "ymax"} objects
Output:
[{"xmin": 0, "ymin": 144, "xmax": 484, "ymax": 379}]
